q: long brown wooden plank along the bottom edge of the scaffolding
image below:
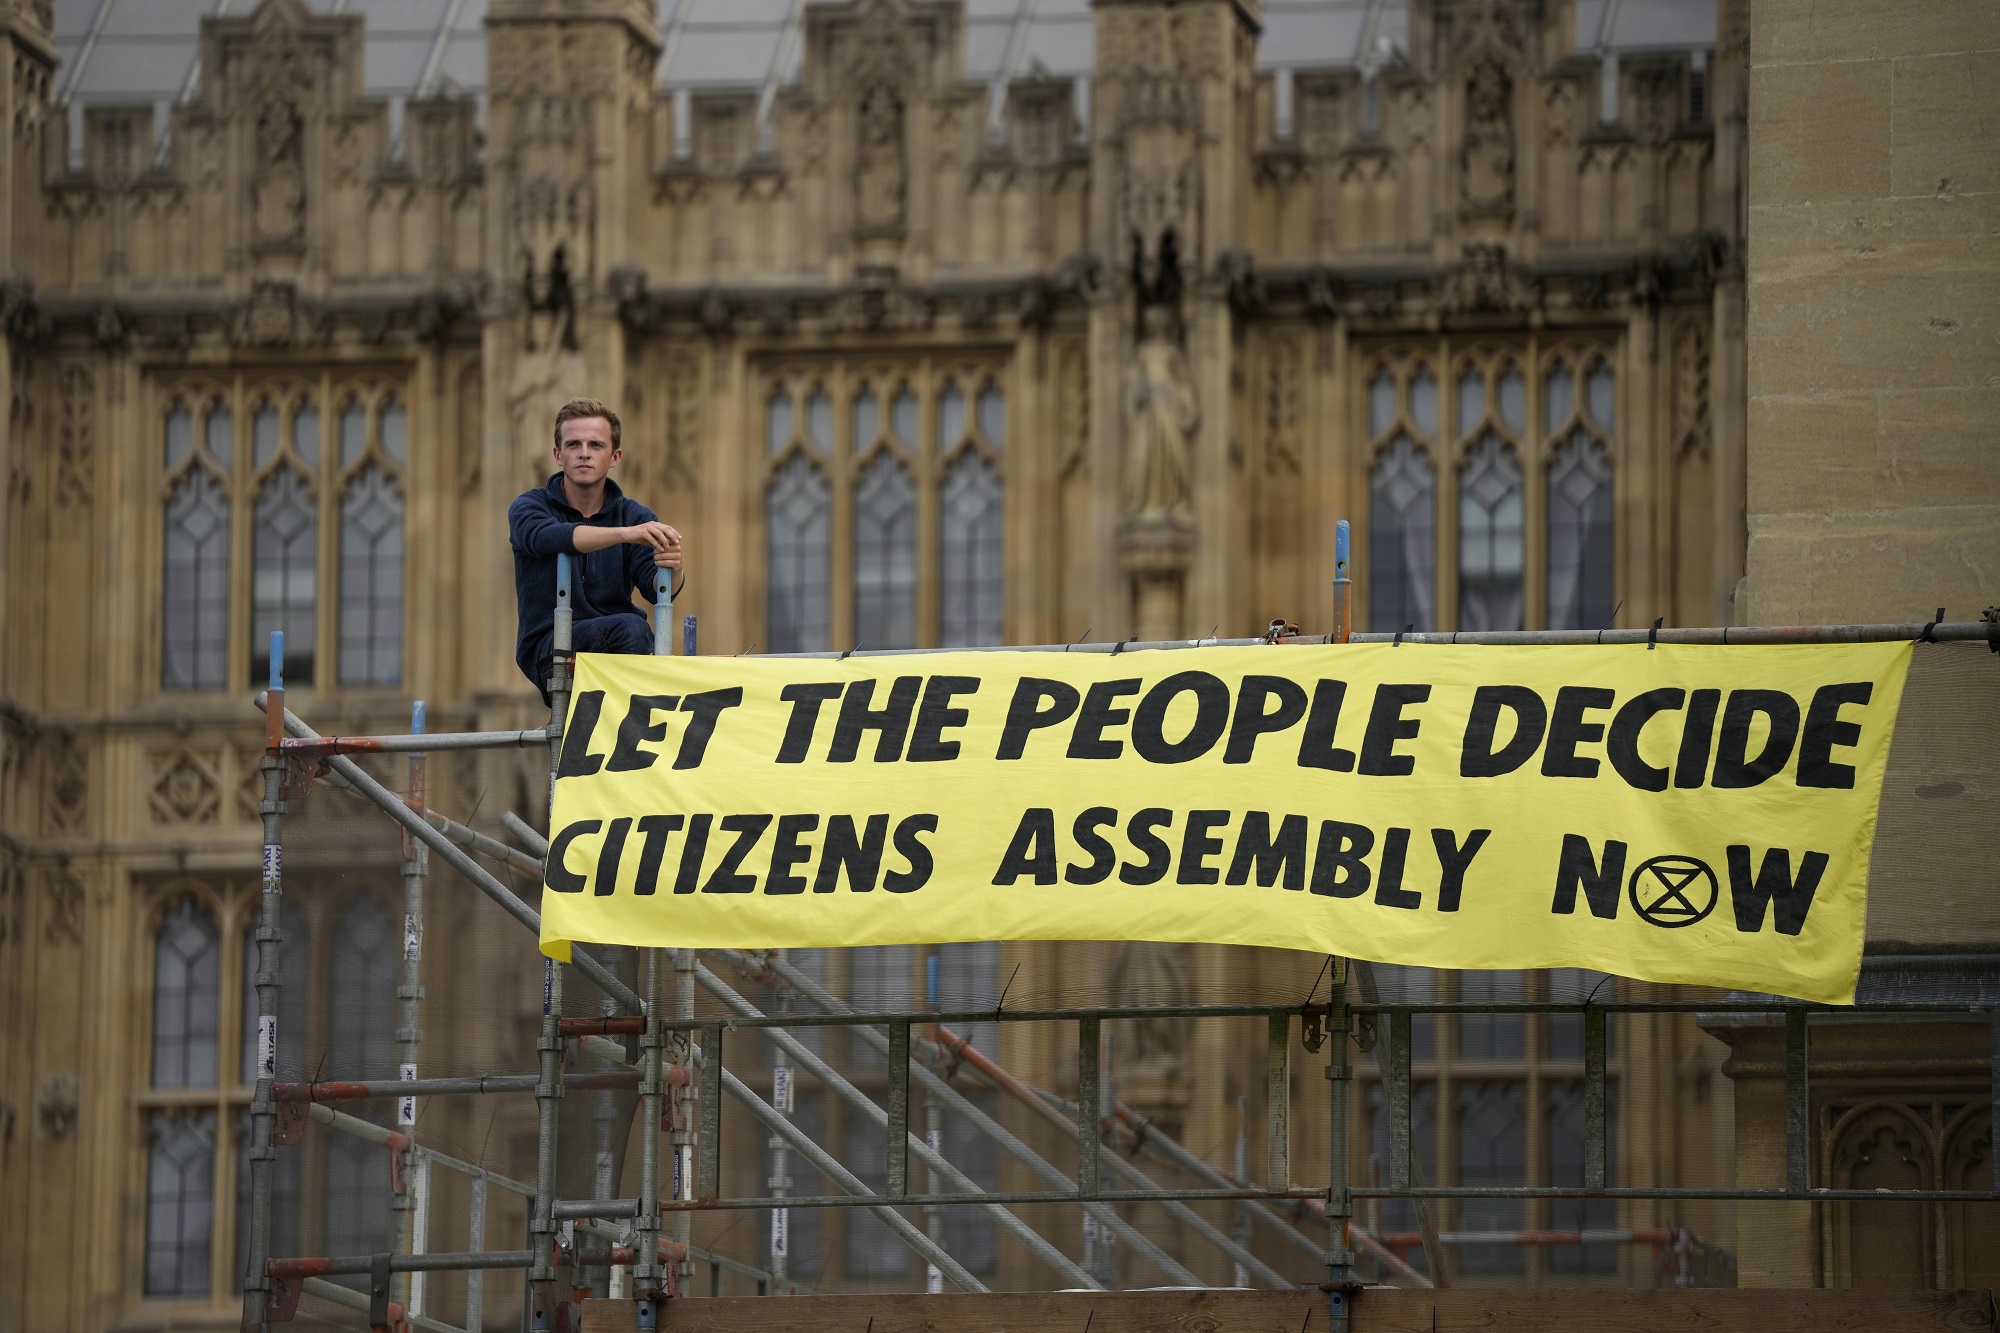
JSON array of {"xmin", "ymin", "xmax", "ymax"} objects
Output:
[{"xmin": 584, "ymin": 1287, "xmax": 1996, "ymax": 1333}]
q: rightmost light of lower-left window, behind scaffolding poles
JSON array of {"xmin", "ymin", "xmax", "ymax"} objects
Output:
[{"xmin": 322, "ymin": 895, "xmax": 402, "ymax": 1255}]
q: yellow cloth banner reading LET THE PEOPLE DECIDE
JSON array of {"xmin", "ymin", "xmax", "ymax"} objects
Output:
[{"xmin": 542, "ymin": 642, "xmax": 1910, "ymax": 1003}]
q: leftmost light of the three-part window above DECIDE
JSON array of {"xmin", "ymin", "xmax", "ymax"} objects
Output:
[{"xmin": 1368, "ymin": 364, "xmax": 1438, "ymax": 630}]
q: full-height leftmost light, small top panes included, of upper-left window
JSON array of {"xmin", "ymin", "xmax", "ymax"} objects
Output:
[{"xmin": 160, "ymin": 398, "xmax": 230, "ymax": 691}]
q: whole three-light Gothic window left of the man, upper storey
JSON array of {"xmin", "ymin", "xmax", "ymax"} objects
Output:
[{"xmin": 160, "ymin": 376, "xmax": 408, "ymax": 691}]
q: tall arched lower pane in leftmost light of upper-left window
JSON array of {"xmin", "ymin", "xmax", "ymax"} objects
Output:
[{"xmin": 160, "ymin": 466, "xmax": 230, "ymax": 691}]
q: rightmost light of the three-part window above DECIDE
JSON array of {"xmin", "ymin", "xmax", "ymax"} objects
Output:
[{"xmin": 1548, "ymin": 358, "xmax": 1616, "ymax": 628}]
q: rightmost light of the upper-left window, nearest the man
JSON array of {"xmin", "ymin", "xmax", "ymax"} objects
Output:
[{"xmin": 340, "ymin": 394, "xmax": 408, "ymax": 687}]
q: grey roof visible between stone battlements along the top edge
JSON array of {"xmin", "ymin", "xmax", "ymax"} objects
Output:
[{"xmin": 54, "ymin": 0, "xmax": 1716, "ymax": 104}]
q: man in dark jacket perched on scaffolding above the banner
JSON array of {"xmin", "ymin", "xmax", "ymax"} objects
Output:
[{"xmin": 508, "ymin": 398, "xmax": 686, "ymax": 703}]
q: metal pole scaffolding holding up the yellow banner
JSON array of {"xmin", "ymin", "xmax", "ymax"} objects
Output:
[{"xmin": 242, "ymin": 522, "xmax": 2000, "ymax": 1333}]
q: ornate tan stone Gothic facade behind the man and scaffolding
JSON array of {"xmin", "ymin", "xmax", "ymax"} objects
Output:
[{"xmin": 0, "ymin": 0, "xmax": 1840, "ymax": 1331}]
